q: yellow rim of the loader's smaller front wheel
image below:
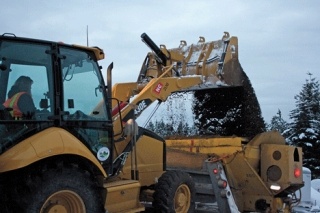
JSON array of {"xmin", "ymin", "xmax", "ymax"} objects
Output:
[{"xmin": 174, "ymin": 184, "xmax": 191, "ymax": 213}]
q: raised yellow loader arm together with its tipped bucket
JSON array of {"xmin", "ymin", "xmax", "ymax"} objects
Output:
[{"xmin": 112, "ymin": 32, "xmax": 242, "ymax": 133}]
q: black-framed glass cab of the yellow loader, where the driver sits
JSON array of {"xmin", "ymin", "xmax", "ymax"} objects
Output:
[{"xmin": 0, "ymin": 35, "xmax": 113, "ymax": 173}]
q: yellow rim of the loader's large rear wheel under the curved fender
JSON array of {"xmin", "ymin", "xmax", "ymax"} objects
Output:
[{"xmin": 40, "ymin": 190, "xmax": 86, "ymax": 213}]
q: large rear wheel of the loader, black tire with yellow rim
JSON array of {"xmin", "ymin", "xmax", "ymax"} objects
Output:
[{"xmin": 14, "ymin": 162, "xmax": 104, "ymax": 213}]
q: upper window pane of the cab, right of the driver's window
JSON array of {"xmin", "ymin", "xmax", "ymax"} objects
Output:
[{"xmin": 60, "ymin": 47, "xmax": 107, "ymax": 120}]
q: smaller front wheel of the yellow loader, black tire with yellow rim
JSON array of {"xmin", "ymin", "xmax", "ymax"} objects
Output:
[{"xmin": 153, "ymin": 171, "xmax": 195, "ymax": 213}]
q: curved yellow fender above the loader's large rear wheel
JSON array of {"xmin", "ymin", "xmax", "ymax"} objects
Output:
[{"xmin": 0, "ymin": 127, "xmax": 107, "ymax": 177}]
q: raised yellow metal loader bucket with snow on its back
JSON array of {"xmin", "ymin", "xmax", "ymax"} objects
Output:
[{"xmin": 169, "ymin": 33, "xmax": 243, "ymax": 87}]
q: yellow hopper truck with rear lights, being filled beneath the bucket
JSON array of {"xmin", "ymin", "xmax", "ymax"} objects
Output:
[{"xmin": 166, "ymin": 134, "xmax": 303, "ymax": 212}]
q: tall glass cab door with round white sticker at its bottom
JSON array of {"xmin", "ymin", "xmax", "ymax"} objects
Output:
[{"xmin": 60, "ymin": 47, "xmax": 113, "ymax": 174}]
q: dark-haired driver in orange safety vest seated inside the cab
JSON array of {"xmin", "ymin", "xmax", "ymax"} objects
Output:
[{"xmin": 3, "ymin": 76, "xmax": 36, "ymax": 120}]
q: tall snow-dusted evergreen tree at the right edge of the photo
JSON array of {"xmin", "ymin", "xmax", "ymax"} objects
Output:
[{"xmin": 287, "ymin": 73, "xmax": 320, "ymax": 178}]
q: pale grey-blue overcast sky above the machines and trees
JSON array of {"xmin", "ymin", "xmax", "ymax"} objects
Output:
[{"xmin": 0, "ymin": 0, "xmax": 320, "ymax": 123}]
